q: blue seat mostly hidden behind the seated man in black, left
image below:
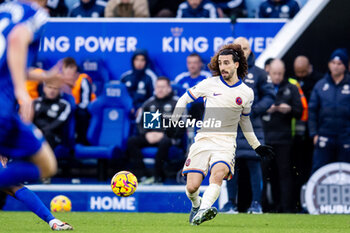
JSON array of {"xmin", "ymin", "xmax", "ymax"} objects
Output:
[{"xmin": 54, "ymin": 93, "xmax": 76, "ymax": 159}]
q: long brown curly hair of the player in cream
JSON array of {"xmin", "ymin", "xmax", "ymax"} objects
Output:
[{"xmin": 208, "ymin": 44, "xmax": 248, "ymax": 80}]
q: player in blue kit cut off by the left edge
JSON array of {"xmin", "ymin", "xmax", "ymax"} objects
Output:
[{"xmin": 0, "ymin": 0, "xmax": 72, "ymax": 230}]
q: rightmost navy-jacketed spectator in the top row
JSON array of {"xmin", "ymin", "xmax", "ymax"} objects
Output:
[{"xmin": 259, "ymin": 0, "xmax": 300, "ymax": 19}]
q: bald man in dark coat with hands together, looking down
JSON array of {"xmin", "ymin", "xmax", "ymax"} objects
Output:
[{"xmin": 262, "ymin": 59, "xmax": 303, "ymax": 213}]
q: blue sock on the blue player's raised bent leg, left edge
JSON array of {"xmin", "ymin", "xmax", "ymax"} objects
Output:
[{"xmin": 0, "ymin": 161, "xmax": 40, "ymax": 188}]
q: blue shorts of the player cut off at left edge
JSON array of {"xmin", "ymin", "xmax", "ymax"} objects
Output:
[{"xmin": 0, "ymin": 112, "xmax": 44, "ymax": 159}]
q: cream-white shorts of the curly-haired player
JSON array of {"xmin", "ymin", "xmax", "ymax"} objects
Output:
[{"xmin": 182, "ymin": 133, "xmax": 236, "ymax": 179}]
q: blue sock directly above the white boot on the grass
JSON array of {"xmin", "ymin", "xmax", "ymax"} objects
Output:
[{"xmin": 15, "ymin": 187, "xmax": 55, "ymax": 223}]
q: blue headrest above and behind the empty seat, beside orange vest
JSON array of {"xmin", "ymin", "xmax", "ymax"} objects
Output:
[{"xmin": 80, "ymin": 59, "xmax": 110, "ymax": 96}]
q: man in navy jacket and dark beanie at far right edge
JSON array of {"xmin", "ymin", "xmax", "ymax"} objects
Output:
[{"xmin": 309, "ymin": 49, "xmax": 350, "ymax": 173}]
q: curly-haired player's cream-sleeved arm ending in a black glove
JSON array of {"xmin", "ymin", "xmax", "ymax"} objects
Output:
[{"xmin": 239, "ymin": 90, "xmax": 274, "ymax": 158}]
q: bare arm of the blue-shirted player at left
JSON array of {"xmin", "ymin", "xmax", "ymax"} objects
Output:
[{"xmin": 7, "ymin": 24, "xmax": 33, "ymax": 122}]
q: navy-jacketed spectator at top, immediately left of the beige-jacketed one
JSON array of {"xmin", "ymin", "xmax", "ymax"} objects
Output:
[{"xmin": 68, "ymin": 0, "xmax": 107, "ymax": 18}]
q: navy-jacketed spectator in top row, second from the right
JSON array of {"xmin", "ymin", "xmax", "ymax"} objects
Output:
[{"xmin": 212, "ymin": 0, "xmax": 248, "ymax": 19}]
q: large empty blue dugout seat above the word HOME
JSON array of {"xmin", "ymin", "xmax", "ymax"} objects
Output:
[{"xmin": 75, "ymin": 81, "xmax": 132, "ymax": 159}]
